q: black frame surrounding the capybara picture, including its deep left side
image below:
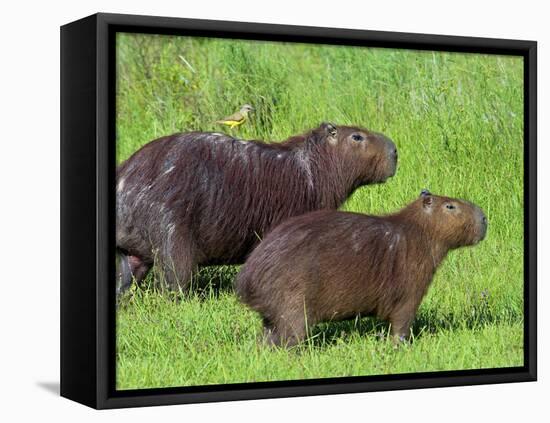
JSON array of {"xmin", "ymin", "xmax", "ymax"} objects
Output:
[{"xmin": 61, "ymin": 13, "xmax": 537, "ymax": 409}]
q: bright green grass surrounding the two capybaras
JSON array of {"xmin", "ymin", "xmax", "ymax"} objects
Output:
[{"xmin": 117, "ymin": 35, "xmax": 523, "ymax": 389}]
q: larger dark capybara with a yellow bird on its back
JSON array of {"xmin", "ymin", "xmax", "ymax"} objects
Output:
[{"xmin": 116, "ymin": 123, "xmax": 397, "ymax": 294}]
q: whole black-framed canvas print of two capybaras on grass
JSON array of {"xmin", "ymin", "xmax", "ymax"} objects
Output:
[{"xmin": 61, "ymin": 14, "xmax": 536, "ymax": 408}]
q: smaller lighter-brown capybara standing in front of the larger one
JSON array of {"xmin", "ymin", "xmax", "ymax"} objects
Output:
[{"xmin": 236, "ymin": 191, "xmax": 487, "ymax": 346}]
